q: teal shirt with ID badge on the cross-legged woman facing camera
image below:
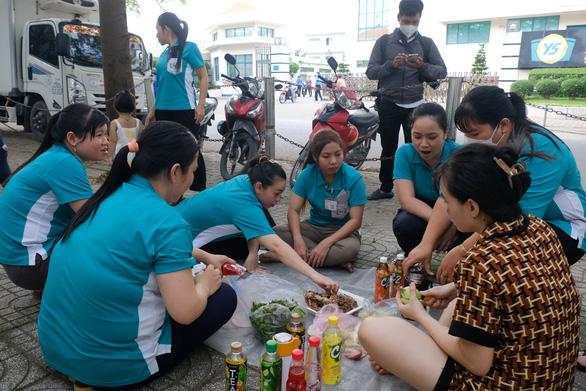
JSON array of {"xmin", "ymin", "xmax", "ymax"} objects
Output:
[{"xmin": 293, "ymin": 163, "xmax": 367, "ymax": 227}]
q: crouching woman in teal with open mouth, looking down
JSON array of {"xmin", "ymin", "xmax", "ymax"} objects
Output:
[{"xmin": 393, "ymin": 103, "xmax": 458, "ymax": 254}]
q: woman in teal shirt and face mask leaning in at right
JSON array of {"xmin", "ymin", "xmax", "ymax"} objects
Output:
[{"xmin": 404, "ymin": 86, "xmax": 586, "ymax": 282}]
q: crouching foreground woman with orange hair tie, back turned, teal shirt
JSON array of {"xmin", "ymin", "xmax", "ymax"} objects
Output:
[{"xmin": 38, "ymin": 121, "xmax": 236, "ymax": 388}]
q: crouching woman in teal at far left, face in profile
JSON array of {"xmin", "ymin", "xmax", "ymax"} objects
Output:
[{"xmin": 0, "ymin": 103, "xmax": 109, "ymax": 291}]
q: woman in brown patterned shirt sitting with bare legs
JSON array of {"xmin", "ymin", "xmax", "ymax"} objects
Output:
[{"xmin": 359, "ymin": 144, "xmax": 580, "ymax": 390}]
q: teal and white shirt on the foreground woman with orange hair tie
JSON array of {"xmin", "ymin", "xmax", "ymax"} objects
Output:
[{"xmin": 38, "ymin": 176, "xmax": 195, "ymax": 387}]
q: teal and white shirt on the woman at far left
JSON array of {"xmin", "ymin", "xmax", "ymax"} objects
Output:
[{"xmin": 0, "ymin": 144, "xmax": 92, "ymax": 266}]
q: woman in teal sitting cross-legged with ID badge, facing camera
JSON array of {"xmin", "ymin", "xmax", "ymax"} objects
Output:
[{"xmin": 266, "ymin": 130, "xmax": 367, "ymax": 271}]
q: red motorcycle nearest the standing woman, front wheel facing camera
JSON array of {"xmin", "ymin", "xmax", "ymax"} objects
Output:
[{"xmin": 218, "ymin": 54, "xmax": 265, "ymax": 179}]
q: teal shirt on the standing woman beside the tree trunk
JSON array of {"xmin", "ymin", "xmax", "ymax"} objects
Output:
[{"xmin": 155, "ymin": 42, "xmax": 205, "ymax": 110}]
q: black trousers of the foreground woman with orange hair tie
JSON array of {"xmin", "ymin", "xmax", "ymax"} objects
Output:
[{"xmin": 93, "ymin": 283, "xmax": 237, "ymax": 390}]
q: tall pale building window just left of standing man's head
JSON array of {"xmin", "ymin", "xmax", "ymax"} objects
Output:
[{"xmin": 358, "ymin": 0, "xmax": 390, "ymax": 41}]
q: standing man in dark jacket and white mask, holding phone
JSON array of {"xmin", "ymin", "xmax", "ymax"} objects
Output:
[{"xmin": 366, "ymin": 0, "xmax": 447, "ymax": 200}]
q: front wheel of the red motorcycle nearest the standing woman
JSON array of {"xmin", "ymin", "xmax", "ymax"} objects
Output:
[{"xmin": 220, "ymin": 133, "xmax": 256, "ymax": 180}]
